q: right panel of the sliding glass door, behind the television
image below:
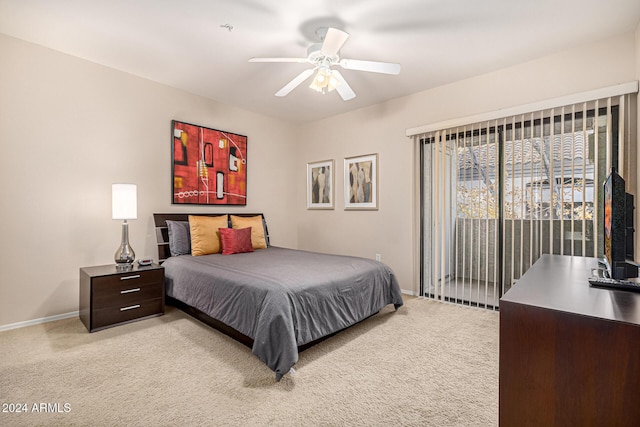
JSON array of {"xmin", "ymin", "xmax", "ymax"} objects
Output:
[{"xmin": 501, "ymin": 107, "xmax": 618, "ymax": 292}]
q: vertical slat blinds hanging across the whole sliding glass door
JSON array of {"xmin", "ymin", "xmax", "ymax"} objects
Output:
[{"xmin": 413, "ymin": 84, "xmax": 637, "ymax": 309}]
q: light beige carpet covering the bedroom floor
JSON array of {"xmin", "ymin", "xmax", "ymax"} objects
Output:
[{"xmin": 0, "ymin": 298, "xmax": 498, "ymax": 426}]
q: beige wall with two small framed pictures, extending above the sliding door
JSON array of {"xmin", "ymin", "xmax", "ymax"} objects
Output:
[{"xmin": 297, "ymin": 32, "xmax": 638, "ymax": 292}]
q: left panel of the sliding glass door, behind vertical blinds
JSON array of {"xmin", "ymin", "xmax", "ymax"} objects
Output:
[{"xmin": 421, "ymin": 128, "xmax": 500, "ymax": 307}]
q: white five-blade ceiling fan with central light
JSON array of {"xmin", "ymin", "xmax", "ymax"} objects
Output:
[{"xmin": 249, "ymin": 27, "xmax": 400, "ymax": 101}]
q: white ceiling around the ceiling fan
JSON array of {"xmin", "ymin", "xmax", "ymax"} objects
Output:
[{"xmin": 0, "ymin": 0, "xmax": 640, "ymax": 122}]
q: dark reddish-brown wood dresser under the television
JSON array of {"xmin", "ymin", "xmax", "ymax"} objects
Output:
[{"xmin": 499, "ymin": 255, "xmax": 640, "ymax": 427}]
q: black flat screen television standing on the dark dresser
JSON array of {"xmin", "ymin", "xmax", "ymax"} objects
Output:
[{"xmin": 604, "ymin": 168, "xmax": 638, "ymax": 280}]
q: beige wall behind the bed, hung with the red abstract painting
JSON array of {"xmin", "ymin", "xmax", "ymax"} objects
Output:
[{"xmin": 0, "ymin": 35, "xmax": 297, "ymax": 326}]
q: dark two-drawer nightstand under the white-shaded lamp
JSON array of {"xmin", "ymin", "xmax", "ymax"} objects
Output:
[{"xmin": 80, "ymin": 264, "xmax": 164, "ymax": 332}]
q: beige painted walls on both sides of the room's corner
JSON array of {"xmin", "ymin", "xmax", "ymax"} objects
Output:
[{"xmin": 0, "ymin": 28, "xmax": 640, "ymax": 326}]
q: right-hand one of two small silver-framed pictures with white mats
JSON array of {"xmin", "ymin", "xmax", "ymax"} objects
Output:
[{"xmin": 344, "ymin": 154, "xmax": 378, "ymax": 210}]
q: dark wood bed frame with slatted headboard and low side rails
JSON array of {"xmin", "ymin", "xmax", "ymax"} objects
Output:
[{"xmin": 153, "ymin": 213, "xmax": 328, "ymax": 353}]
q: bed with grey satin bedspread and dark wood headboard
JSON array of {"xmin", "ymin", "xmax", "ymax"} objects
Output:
[{"xmin": 154, "ymin": 213, "xmax": 403, "ymax": 381}]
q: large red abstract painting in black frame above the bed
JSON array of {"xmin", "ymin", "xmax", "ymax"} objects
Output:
[{"xmin": 171, "ymin": 120, "xmax": 247, "ymax": 206}]
